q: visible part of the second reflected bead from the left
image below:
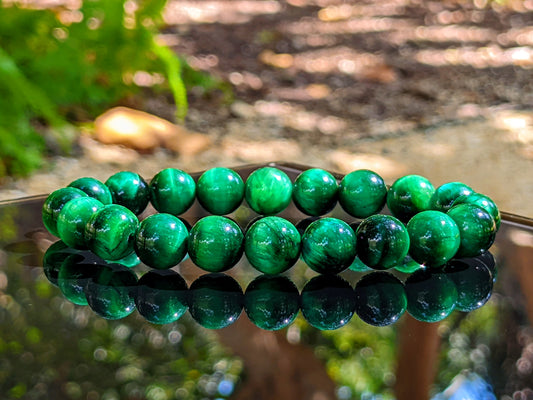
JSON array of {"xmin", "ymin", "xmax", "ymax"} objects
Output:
[{"xmin": 57, "ymin": 256, "xmax": 98, "ymax": 306}]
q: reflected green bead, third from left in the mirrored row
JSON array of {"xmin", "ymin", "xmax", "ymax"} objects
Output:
[{"xmin": 85, "ymin": 264, "xmax": 137, "ymax": 319}]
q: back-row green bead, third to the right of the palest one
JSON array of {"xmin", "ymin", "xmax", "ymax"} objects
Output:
[{"xmin": 387, "ymin": 175, "xmax": 435, "ymax": 222}]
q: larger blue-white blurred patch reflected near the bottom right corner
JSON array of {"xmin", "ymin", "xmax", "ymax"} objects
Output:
[{"xmin": 431, "ymin": 372, "xmax": 496, "ymax": 400}]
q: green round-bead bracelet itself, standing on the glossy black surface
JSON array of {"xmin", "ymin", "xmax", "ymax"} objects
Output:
[{"xmin": 43, "ymin": 167, "xmax": 500, "ymax": 274}]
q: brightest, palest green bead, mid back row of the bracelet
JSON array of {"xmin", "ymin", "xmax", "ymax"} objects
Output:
[{"xmin": 245, "ymin": 167, "xmax": 292, "ymax": 215}]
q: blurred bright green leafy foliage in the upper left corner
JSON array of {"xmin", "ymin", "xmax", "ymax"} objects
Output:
[{"xmin": 0, "ymin": 0, "xmax": 193, "ymax": 178}]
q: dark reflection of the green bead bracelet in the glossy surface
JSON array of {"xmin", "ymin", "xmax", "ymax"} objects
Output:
[{"xmin": 43, "ymin": 241, "xmax": 496, "ymax": 330}]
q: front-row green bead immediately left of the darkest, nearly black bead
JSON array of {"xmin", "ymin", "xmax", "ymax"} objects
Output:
[{"xmin": 302, "ymin": 218, "xmax": 356, "ymax": 274}]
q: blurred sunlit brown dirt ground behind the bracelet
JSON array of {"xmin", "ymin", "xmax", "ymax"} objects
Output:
[{"xmin": 0, "ymin": 0, "xmax": 533, "ymax": 217}]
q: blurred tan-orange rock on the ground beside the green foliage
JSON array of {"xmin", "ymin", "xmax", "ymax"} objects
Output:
[{"xmin": 94, "ymin": 107, "xmax": 211, "ymax": 155}]
